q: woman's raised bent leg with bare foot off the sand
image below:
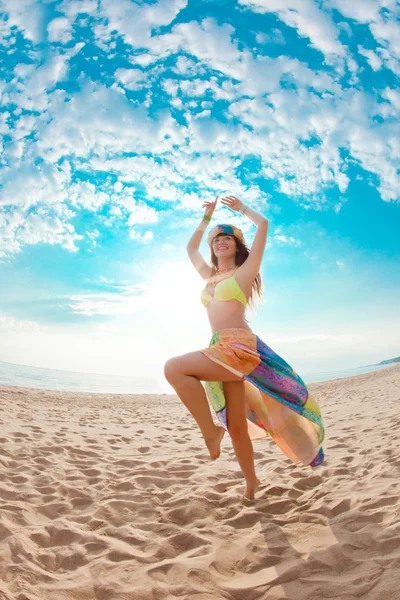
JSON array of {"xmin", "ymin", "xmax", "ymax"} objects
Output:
[{"xmin": 164, "ymin": 352, "xmax": 242, "ymax": 460}]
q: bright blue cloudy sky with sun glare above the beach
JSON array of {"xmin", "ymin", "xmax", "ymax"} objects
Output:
[{"xmin": 0, "ymin": 0, "xmax": 400, "ymax": 391}]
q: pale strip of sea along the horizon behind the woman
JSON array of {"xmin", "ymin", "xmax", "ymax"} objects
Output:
[{"xmin": 0, "ymin": 361, "xmax": 394, "ymax": 394}]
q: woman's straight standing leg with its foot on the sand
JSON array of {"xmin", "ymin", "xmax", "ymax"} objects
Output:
[{"xmin": 223, "ymin": 381, "xmax": 260, "ymax": 500}]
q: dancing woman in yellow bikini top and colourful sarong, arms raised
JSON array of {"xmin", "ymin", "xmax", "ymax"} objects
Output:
[{"xmin": 165, "ymin": 196, "xmax": 324, "ymax": 499}]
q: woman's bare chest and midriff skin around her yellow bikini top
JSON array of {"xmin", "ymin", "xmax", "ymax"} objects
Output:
[{"xmin": 205, "ymin": 267, "xmax": 253, "ymax": 334}]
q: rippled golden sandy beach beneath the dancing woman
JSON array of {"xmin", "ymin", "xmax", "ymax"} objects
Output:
[{"xmin": 0, "ymin": 365, "xmax": 400, "ymax": 600}]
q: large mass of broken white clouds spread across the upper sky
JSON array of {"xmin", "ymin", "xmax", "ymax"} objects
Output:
[{"xmin": 0, "ymin": 0, "xmax": 398, "ymax": 264}]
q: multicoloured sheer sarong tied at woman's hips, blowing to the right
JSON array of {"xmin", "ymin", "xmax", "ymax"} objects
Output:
[{"xmin": 201, "ymin": 328, "xmax": 325, "ymax": 467}]
